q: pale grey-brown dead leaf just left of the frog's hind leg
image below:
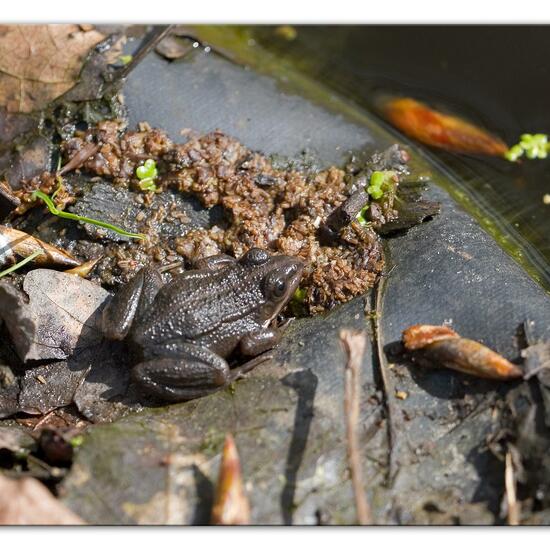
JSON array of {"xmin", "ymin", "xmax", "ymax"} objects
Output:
[{"xmin": 0, "ymin": 269, "xmax": 109, "ymax": 362}]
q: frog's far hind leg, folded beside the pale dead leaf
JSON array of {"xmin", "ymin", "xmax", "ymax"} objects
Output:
[{"xmin": 102, "ymin": 266, "xmax": 163, "ymax": 340}]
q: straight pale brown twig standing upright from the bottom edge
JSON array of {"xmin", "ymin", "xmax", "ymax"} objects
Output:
[{"xmin": 340, "ymin": 329, "xmax": 372, "ymax": 525}]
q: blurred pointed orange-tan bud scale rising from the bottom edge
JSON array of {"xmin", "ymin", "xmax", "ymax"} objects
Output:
[{"xmin": 211, "ymin": 434, "xmax": 250, "ymax": 525}]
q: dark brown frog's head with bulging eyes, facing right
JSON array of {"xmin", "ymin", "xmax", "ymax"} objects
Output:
[{"xmin": 239, "ymin": 248, "xmax": 304, "ymax": 325}]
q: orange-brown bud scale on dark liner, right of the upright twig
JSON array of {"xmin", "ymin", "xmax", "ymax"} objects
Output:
[{"xmin": 403, "ymin": 325, "xmax": 523, "ymax": 380}]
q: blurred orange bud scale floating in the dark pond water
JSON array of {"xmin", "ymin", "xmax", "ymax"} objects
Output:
[{"xmin": 382, "ymin": 97, "xmax": 508, "ymax": 156}]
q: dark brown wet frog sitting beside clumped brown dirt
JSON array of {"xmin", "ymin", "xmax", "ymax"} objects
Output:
[{"xmin": 101, "ymin": 248, "xmax": 304, "ymax": 402}]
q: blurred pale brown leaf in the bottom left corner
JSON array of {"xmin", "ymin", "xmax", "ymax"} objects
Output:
[{"xmin": 0, "ymin": 476, "xmax": 85, "ymax": 525}]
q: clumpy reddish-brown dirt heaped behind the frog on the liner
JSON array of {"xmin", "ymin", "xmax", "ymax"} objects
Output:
[{"xmin": 14, "ymin": 121, "xmax": 426, "ymax": 314}]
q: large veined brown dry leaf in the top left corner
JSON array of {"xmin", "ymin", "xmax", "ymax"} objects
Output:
[{"xmin": 0, "ymin": 25, "xmax": 105, "ymax": 113}]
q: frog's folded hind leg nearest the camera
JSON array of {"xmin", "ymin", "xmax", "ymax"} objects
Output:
[{"xmin": 132, "ymin": 341, "xmax": 232, "ymax": 401}]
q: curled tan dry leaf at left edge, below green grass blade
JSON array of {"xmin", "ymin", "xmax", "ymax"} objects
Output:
[{"xmin": 0, "ymin": 225, "xmax": 80, "ymax": 267}]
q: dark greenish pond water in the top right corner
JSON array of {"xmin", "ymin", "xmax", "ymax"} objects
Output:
[{"xmin": 246, "ymin": 26, "xmax": 550, "ymax": 289}]
